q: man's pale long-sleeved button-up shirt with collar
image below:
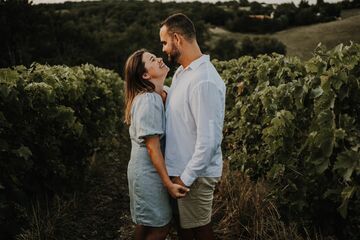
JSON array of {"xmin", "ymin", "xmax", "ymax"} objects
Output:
[{"xmin": 165, "ymin": 55, "xmax": 226, "ymax": 186}]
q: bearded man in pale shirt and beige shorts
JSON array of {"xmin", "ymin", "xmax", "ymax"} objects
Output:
[{"xmin": 160, "ymin": 14, "xmax": 225, "ymax": 240}]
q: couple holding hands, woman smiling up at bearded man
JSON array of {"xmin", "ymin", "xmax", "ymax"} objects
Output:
[{"xmin": 125, "ymin": 14, "xmax": 225, "ymax": 239}]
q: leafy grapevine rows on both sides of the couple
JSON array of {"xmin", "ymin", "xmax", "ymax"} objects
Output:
[{"xmin": 0, "ymin": 44, "xmax": 360, "ymax": 240}]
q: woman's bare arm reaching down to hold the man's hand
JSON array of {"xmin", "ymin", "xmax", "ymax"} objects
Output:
[{"xmin": 145, "ymin": 136, "xmax": 189, "ymax": 198}]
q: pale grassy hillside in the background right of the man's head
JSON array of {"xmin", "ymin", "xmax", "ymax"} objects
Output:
[{"xmin": 207, "ymin": 9, "xmax": 360, "ymax": 60}]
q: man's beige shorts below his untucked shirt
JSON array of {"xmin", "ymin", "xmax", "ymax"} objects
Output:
[{"xmin": 177, "ymin": 177, "xmax": 220, "ymax": 228}]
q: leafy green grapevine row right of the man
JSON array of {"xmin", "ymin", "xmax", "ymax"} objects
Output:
[{"xmin": 215, "ymin": 44, "xmax": 360, "ymax": 239}]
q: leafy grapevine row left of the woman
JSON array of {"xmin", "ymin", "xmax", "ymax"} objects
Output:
[{"xmin": 0, "ymin": 64, "xmax": 123, "ymax": 236}]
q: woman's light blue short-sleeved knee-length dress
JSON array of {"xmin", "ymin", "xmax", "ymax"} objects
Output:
[{"xmin": 127, "ymin": 92, "xmax": 172, "ymax": 227}]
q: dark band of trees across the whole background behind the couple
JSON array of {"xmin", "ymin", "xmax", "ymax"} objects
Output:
[{"xmin": 0, "ymin": 0, "xmax": 351, "ymax": 75}]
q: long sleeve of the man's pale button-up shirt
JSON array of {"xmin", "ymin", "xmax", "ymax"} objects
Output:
[{"xmin": 180, "ymin": 81, "xmax": 225, "ymax": 186}]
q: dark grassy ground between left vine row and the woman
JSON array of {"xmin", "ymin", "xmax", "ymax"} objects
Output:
[{"xmin": 16, "ymin": 136, "xmax": 133, "ymax": 240}]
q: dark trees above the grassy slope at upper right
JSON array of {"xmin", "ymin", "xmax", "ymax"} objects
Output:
[{"xmin": 204, "ymin": 0, "xmax": 360, "ymax": 33}]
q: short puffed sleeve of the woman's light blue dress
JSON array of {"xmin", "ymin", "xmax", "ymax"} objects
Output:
[{"xmin": 132, "ymin": 93, "xmax": 164, "ymax": 140}]
